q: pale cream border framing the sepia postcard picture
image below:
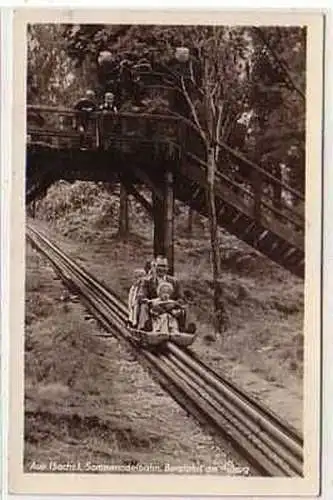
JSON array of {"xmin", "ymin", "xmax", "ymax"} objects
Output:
[{"xmin": 8, "ymin": 9, "xmax": 323, "ymax": 496}]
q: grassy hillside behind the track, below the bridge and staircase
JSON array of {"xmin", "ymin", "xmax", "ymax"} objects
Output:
[{"xmin": 31, "ymin": 182, "xmax": 303, "ymax": 420}]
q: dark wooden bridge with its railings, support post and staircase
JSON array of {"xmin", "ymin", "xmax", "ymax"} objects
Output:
[{"xmin": 26, "ymin": 106, "xmax": 305, "ymax": 278}]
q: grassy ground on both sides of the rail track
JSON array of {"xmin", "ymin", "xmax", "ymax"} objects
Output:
[{"xmin": 25, "ymin": 184, "xmax": 303, "ymax": 470}]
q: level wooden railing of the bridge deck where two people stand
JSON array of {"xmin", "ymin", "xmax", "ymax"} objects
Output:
[{"xmin": 27, "ymin": 106, "xmax": 184, "ymax": 157}]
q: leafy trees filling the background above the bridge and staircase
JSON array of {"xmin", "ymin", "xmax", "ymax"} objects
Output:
[{"xmin": 28, "ymin": 24, "xmax": 306, "ymax": 190}]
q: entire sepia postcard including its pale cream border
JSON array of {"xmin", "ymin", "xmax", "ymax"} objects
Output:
[{"xmin": 10, "ymin": 6, "xmax": 323, "ymax": 495}]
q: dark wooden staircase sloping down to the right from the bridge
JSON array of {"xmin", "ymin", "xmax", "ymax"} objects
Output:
[{"xmin": 175, "ymin": 150, "xmax": 304, "ymax": 278}]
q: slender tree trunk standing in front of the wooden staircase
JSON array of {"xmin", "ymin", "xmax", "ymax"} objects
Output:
[{"xmin": 207, "ymin": 147, "xmax": 226, "ymax": 334}]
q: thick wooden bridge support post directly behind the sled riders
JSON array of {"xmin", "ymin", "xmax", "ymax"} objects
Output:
[{"xmin": 152, "ymin": 171, "xmax": 175, "ymax": 274}]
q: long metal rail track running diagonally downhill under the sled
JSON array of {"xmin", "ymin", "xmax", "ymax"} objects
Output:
[{"xmin": 27, "ymin": 226, "xmax": 303, "ymax": 477}]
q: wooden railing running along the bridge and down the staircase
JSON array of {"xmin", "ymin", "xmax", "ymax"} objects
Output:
[{"xmin": 27, "ymin": 106, "xmax": 305, "ymax": 233}]
